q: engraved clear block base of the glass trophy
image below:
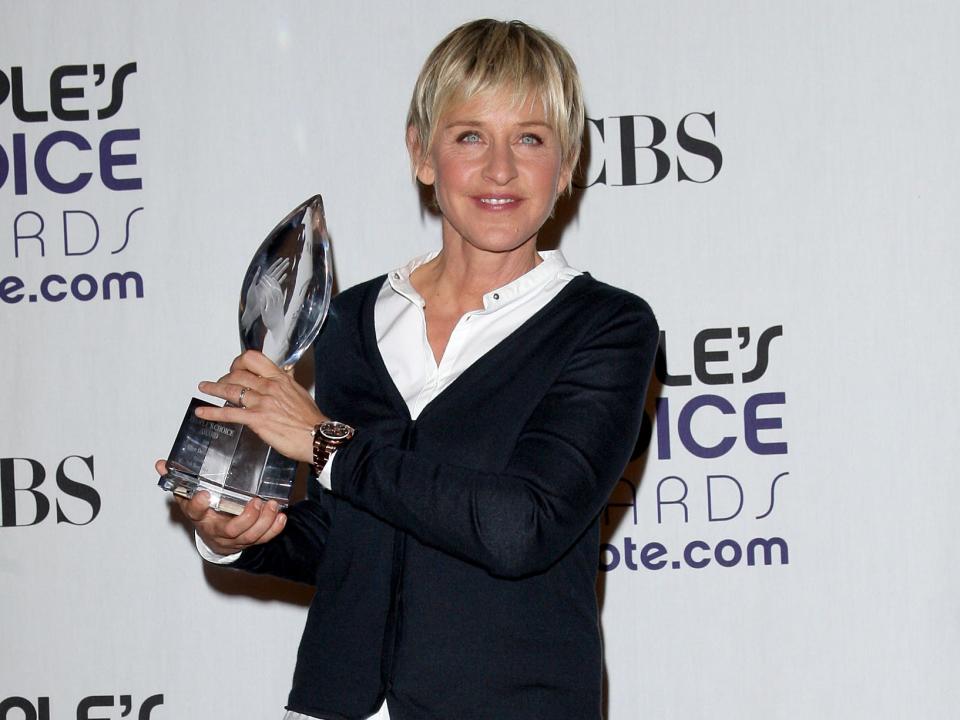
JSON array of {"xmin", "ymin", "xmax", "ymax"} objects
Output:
[{"xmin": 159, "ymin": 398, "xmax": 297, "ymax": 515}]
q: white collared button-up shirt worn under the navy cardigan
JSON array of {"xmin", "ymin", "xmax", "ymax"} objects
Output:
[{"xmin": 196, "ymin": 250, "xmax": 580, "ymax": 720}]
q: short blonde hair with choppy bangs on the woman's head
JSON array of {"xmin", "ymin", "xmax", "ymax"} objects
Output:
[{"xmin": 407, "ymin": 20, "xmax": 584, "ymax": 183}]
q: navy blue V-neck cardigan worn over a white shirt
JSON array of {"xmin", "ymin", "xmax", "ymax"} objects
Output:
[{"xmin": 235, "ymin": 275, "xmax": 658, "ymax": 720}]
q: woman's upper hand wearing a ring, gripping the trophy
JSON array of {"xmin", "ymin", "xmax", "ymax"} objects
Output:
[{"xmin": 197, "ymin": 350, "xmax": 327, "ymax": 462}]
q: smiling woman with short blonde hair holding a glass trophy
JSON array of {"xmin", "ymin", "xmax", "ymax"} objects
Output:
[{"xmin": 161, "ymin": 20, "xmax": 658, "ymax": 720}]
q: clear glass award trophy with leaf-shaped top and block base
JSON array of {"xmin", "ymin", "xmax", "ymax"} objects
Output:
[{"xmin": 160, "ymin": 195, "xmax": 333, "ymax": 515}]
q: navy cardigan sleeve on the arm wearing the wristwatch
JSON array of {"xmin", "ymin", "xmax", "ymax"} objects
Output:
[{"xmin": 332, "ymin": 293, "xmax": 659, "ymax": 577}]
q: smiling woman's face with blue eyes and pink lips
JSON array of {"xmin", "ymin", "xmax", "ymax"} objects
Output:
[{"xmin": 417, "ymin": 90, "xmax": 570, "ymax": 253}]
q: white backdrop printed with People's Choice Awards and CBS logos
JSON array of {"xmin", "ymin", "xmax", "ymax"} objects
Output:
[{"xmin": 0, "ymin": 0, "xmax": 960, "ymax": 720}]
